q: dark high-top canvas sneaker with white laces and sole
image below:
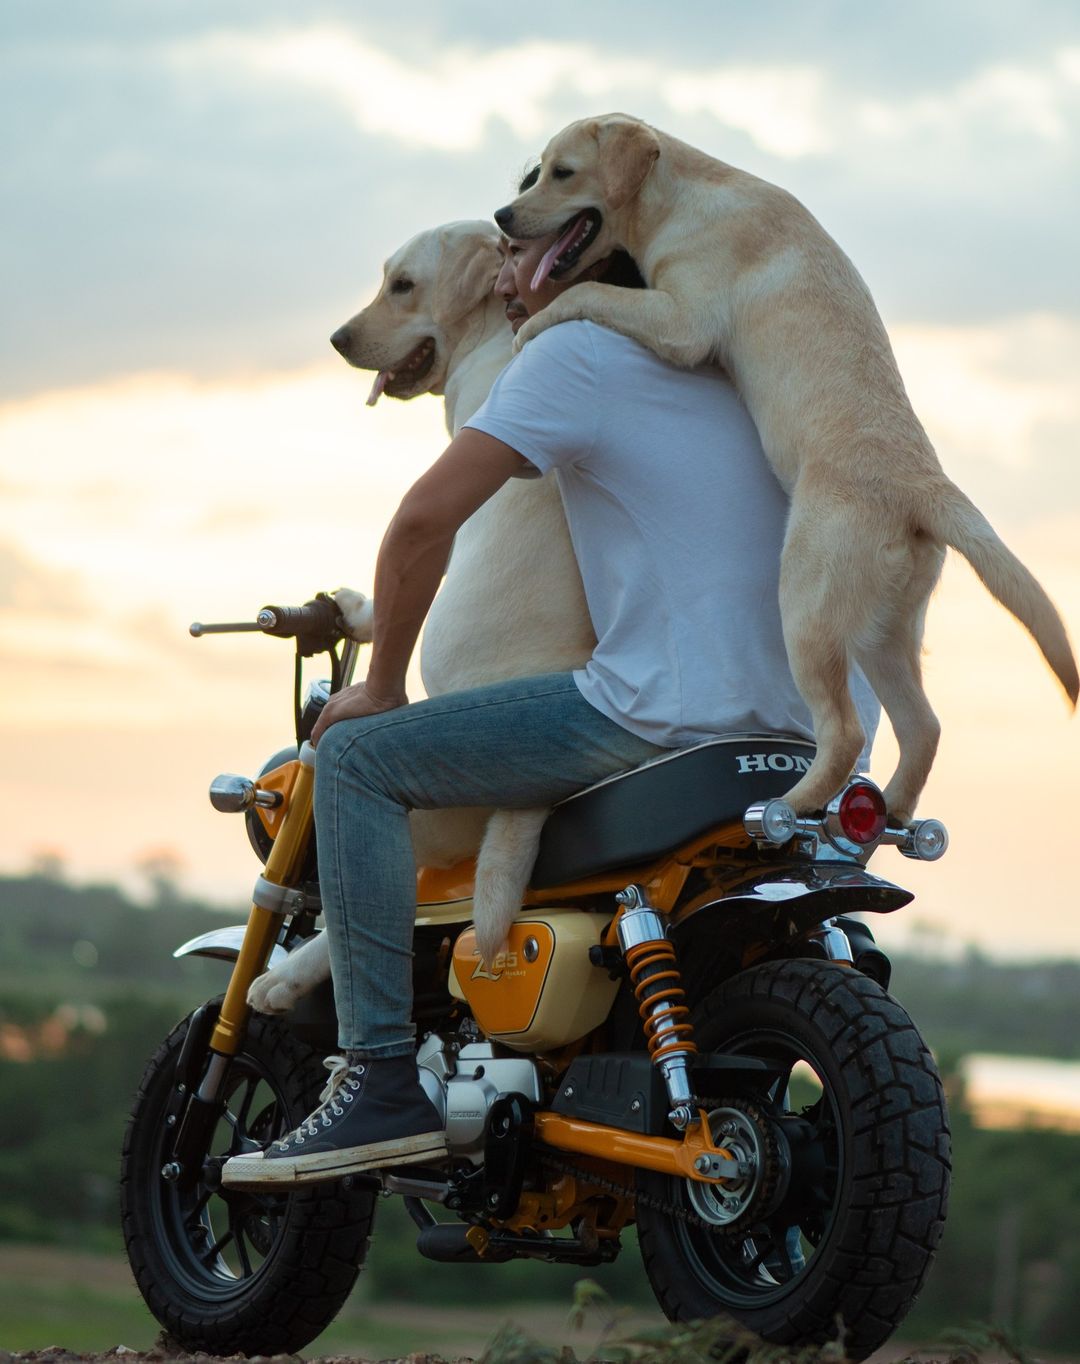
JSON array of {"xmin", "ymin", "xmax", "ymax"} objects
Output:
[{"xmin": 221, "ymin": 1056, "xmax": 447, "ymax": 1188}]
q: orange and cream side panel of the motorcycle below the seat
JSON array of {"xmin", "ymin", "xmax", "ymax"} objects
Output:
[{"xmin": 450, "ymin": 908, "xmax": 619, "ymax": 1052}]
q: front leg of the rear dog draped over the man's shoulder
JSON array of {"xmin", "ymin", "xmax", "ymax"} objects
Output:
[{"xmin": 514, "ymin": 281, "xmax": 716, "ymax": 368}]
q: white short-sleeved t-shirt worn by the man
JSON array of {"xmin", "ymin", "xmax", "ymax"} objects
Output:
[{"xmin": 466, "ymin": 322, "xmax": 878, "ymax": 752}]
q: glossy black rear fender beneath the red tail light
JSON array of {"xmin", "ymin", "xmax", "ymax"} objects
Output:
[{"xmin": 675, "ymin": 862, "xmax": 915, "ymax": 929}]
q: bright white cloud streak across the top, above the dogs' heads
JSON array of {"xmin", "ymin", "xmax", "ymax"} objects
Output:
[{"xmin": 168, "ymin": 23, "xmax": 1080, "ymax": 158}]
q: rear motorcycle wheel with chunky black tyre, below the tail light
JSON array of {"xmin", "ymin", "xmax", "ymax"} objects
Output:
[{"xmin": 638, "ymin": 960, "xmax": 950, "ymax": 1360}]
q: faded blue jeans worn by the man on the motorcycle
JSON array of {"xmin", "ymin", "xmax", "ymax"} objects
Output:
[{"xmin": 315, "ymin": 672, "xmax": 668, "ymax": 1057}]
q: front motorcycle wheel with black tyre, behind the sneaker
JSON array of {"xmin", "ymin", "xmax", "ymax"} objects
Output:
[{"xmin": 120, "ymin": 1013, "xmax": 375, "ymax": 1354}]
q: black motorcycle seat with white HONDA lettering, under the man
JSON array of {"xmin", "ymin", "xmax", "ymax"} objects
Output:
[{"xmin": 529, "ymin": 734, "xmax": 814, "ymax": 889}]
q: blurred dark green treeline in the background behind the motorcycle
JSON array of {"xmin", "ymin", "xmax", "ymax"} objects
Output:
[{"xmin": 0, "ymin": 874, "xmax": 1080, "ymax": 1350}]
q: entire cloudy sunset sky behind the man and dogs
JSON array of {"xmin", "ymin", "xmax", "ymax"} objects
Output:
[{"xmin": 0, "ymin": 0, "xmax": 1080, "ymax": 958}]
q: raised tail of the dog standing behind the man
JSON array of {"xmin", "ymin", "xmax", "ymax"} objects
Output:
[{"xmin": 922, "ymin": 480, "xmax": 1080, "ymax": 708}]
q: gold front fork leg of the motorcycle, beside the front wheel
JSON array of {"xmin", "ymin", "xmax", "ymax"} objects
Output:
[{"xmin": 161, "ymin": 743, "xmax": 315, "ymax": 1183}]
